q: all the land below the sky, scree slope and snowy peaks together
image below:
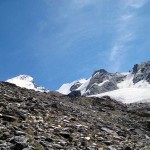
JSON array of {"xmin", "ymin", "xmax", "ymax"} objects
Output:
[{"xmin": 0, "ymin": 62, "xmax": 150, "ymax": 150}]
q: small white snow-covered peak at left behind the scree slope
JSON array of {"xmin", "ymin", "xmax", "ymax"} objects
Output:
[{"xmin": 6, "ymin": 75, "xmax": 48, "ymax": 92}]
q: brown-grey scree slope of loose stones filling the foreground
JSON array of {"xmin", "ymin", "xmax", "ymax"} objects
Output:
[{"xmin": 0, "ymin": 82, "xmax": 150, "ymax": 150}]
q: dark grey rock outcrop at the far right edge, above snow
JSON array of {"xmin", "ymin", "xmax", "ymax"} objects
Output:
[{"xmin": 132, "ymin": 61, "xmax": 150, "ymax": 83}]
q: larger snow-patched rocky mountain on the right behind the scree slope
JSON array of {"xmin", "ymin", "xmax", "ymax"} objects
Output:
[{"xmin": 58, "ymin": 61, "xmax": 150, "ymax": 103}]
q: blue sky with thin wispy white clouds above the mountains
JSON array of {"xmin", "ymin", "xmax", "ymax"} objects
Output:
[{"xmin": 0, "ymin": 0, "xmax": 150, "ymax": 90}]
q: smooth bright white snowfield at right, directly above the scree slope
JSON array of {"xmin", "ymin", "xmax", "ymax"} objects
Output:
[{"xmin": 89, "ymin": 88, "xmax": 150, "ymax": 103}]
